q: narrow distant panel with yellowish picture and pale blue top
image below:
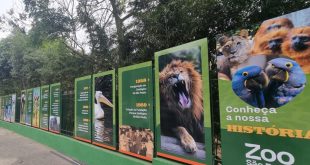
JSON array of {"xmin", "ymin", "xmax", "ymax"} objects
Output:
[{"xmin": 32, "ymin": 87, "xmax": 41, "ymax": 128}]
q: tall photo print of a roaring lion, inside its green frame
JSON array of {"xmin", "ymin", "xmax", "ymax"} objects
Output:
[{"xmin": 159, "ymin": 47, "xmax": 205, "ymax": 160}]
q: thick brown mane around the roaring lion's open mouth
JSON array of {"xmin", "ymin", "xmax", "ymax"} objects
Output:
[{"xmin": 159, "ymin": 60, "xmax": 203, "ymax": 140}]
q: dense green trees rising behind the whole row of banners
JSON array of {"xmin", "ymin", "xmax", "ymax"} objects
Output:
[{"xmin": 0, "ymin": 0, "xmax": 310, "ymax": 94}]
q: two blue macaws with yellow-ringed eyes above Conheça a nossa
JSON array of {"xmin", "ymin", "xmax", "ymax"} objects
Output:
[{"xmin": 232, "ymin": 58, "xmax": 307, "ymax": 108}]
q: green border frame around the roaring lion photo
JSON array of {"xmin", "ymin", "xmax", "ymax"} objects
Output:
[{"xmin": 154, "ymin": 38, "xmax": 214, "ymax": 165}]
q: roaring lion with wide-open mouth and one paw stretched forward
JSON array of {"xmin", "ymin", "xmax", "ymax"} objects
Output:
[{"xmin": 159, "ymin": 60, "xmax": 204, "ymax": 153}]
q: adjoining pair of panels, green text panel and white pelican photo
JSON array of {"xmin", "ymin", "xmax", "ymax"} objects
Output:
[{"xmin": 74, "ymin": 70, "xmax": 117, "ymax": 150}]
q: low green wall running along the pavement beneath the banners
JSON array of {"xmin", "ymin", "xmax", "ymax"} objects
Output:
[{"xmin": 0, "ymin": 121, "xmax": 178, "ymax": 165}]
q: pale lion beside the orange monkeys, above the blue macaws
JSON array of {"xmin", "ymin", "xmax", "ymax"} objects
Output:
[{"xmin": 218, "ymin": 36, "xmax": 267, "ymax": 80}]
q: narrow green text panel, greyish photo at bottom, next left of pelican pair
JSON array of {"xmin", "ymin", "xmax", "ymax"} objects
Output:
[{"xmin": 49, "ymin": 83, "xmax": 61, "ymax": 133}]
